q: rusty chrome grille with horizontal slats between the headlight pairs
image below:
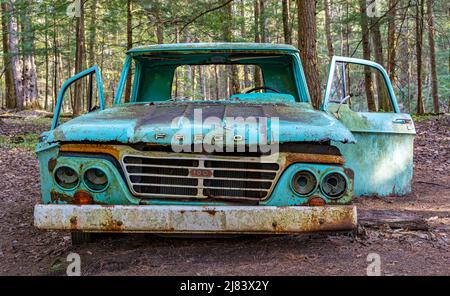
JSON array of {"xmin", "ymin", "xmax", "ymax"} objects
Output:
[{"xmin": 122, "ymin": 153, "xmax": 280, "ymax": 200}]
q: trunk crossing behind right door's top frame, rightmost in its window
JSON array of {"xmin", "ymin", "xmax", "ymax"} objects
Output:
[{"xmin": 372, "ymin": 18, "xmax": 389, "ymax": 111}]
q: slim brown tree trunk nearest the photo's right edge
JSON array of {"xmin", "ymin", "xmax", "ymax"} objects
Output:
[{"xmin": 427, "ymin": 0, "xmax": 439, "ymax": 113}]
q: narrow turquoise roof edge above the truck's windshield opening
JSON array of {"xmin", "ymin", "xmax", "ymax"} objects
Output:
[{"xmin": 127, "ymin": 42, "xmax": 298, "ymax": 55}]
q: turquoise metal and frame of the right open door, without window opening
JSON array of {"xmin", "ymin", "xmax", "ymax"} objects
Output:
[{"xmin": 322, "ymin": 57, "xmax": 416, "ymax": 196}]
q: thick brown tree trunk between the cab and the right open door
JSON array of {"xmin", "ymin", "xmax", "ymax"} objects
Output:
[{"xmin": 297, "ymin": 1, "xmax": 322, "ymax": 108}]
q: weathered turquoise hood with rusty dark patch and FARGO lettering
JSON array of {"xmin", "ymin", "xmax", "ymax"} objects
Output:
[{"xmin": 46, "ymin": 102, "xmax": 356, "ymax": 145}]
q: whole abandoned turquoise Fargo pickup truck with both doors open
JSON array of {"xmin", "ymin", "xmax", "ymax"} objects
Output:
[{"xmin": 34, "ymin": 43, "xmax": 415, "ymax": 241}]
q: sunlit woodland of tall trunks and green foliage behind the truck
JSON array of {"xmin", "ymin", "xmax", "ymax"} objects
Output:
[{"xmin": 0, "ymin": 0, "xmax": 450, "ymax": 114}]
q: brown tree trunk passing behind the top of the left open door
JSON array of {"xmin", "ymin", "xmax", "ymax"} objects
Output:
[{"xmin": 73, "ymin": 4, "xmax": 85, "ymax": 116}]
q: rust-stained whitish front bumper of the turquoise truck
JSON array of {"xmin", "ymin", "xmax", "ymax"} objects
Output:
[{"xmin": 34, "ymin": 204, "xmax": 357, "ymax": 233}]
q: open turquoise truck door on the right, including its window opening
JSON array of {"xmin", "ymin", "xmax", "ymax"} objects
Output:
[{"xmin": 322, "ymin": 56, "xmax": 416, "ymax": 196}]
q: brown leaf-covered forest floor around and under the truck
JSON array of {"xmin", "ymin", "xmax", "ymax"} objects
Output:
[{"xmin": 0, "ymin": 112, "xmax": 450, "ymax": 275}]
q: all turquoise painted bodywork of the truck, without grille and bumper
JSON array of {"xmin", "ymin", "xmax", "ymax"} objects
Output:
[{"xmin": 36, "ymin": 43, "xmax": 415, "ymax": 206}]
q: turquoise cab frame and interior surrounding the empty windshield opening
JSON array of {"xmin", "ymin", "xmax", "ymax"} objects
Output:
[{"xmin": 114, "ymin": 43, "xmax": 310, "ymax": 104}]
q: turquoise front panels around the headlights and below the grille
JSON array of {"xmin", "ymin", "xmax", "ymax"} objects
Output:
[{"xmin": 38, "ymin": 145, "xmax": 353, "ymax": 206}]
